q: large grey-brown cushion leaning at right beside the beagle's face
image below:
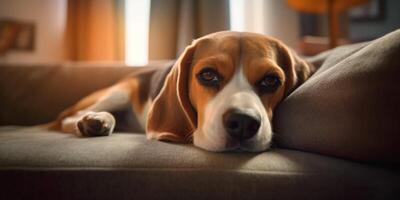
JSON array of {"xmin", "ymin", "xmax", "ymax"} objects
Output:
[{"xmin": 274, "ymin": 30, "xmax": 400, "ymax": 164}]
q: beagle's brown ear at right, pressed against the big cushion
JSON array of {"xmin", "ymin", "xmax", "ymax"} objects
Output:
[{"xmin": 277, "ymin": 41, "xmax": 315, "ymax": 95}]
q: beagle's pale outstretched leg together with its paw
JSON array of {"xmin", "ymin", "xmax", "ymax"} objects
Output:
[{"xmin": 58, "ymin": 80, "xmax": 136, "ymax": 137}]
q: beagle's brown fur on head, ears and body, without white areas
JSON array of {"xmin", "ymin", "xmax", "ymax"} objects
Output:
[{"xmin": 50, "ymin": 32, "xmax": 314, "ymax": 142}]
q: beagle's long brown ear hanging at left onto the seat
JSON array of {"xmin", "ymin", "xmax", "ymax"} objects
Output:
[{"xmin": 147, "ymin": 42, "xmax": 197, "ymax": 142}]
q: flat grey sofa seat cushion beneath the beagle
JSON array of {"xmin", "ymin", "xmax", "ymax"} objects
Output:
[{"xmin": 0, "ymin": 127, "xmax": 400, "ymax": 199}]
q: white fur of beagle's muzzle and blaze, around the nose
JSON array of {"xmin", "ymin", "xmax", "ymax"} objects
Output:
[{"xmin": 193, "ymin": 66, "xmax": 272, "ymax": 151}]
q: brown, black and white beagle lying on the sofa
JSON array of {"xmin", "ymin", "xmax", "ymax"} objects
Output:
[{"xmin": 50, "ymin": 31, "xmax": 315, "ymax": 152}]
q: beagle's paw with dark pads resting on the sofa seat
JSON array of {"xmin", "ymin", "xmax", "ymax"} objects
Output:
[{"xmin": 77, "ymin": 112, "xmax": 115, "ymax": 137}]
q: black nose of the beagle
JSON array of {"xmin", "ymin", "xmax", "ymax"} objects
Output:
[{"xmin": 223, "ymin": 109, "xmax": 260, "ymax": 141}]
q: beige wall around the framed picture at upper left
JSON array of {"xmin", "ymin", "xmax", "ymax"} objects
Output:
[{"xmin": 0, "ymin": 0, "xmax": 67, "ymax": 64}]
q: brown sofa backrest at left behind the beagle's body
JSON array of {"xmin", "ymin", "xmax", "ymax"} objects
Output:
[{"xmin": 0, "ymin": 62, "xmax": 170, "ymax": 125}]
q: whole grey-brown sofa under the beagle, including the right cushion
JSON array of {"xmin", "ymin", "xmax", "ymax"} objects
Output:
[{"xmin": 0, "ymin": 31, "xmax": 400, "ymax": 200}]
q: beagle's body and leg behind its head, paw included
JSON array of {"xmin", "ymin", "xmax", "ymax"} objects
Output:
[{"xmin": 45, "ymin": 67, "xmax": 161, "ymax": 136}]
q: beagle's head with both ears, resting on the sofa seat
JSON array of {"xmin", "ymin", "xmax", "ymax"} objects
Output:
[{"xmin": 147, "ymin": 31, "xmax": 312, "ymax": 152}]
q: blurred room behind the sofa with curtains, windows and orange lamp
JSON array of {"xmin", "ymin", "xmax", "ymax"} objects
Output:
[{"xmin": 0, "ymin": 0, "xmax": 400, "ymax": 66}]
